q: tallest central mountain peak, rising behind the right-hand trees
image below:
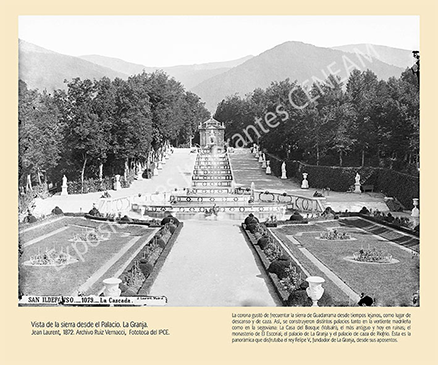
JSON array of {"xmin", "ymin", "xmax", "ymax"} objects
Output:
[{"xmin": 192, "ymin": 42, "xmax": 404, "ymax": 111}]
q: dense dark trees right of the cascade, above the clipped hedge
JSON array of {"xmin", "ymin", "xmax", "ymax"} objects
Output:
[{"xmin": 214, "ymin": 69, "xmax": 420, "ymax": 174}]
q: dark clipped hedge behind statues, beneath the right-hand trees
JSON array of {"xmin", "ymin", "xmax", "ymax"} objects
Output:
[{"xmin": 267, "ymin": 154, "xmax": 420, "ymax": 209}]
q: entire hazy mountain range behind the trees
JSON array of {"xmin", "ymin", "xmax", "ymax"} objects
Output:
[{"xmin": 19, "ymin": 40, "xmax": 414, "ymax": 112}]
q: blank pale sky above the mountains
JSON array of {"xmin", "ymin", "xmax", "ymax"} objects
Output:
[{"xmin": 18, "ymin": 16, "xmax": 420, "ymax": 67}]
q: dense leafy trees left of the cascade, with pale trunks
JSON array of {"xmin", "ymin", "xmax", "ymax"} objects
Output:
[{"xmin": 18, "ymin": 71, "xmax": 210, "ymax": 186}]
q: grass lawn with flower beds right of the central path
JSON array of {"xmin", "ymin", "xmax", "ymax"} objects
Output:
[{"xmin": 278, "ymin": 220, "xmax": 419, "ymax": 306}]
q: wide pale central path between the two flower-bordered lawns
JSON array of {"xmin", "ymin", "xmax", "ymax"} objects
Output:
[{"xmin": 149, "ymin": 220, "xmax": 280, "ymax": 307}]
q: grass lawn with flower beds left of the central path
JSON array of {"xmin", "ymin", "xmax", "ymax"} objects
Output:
[{"xmin": 19, "ymin": 218, "xmax": 154, "ymax": 295}]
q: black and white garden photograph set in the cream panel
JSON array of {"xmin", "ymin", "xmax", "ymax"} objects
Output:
[{"xmin": 17, "ymin": 15, "xmax": 421, "ymax": 307}]
